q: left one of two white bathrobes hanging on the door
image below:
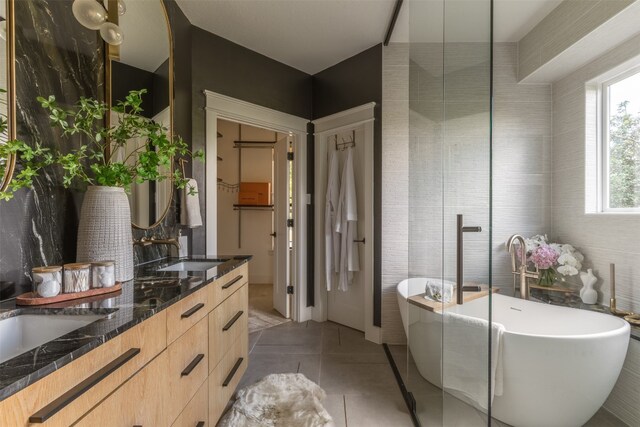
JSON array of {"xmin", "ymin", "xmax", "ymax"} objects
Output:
[{"xmin": 324, "ymin": 146, "xmax": 340, "ymax": 291}]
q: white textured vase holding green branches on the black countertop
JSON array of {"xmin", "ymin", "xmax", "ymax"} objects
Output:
[{"xmin": 76, "ymin": 186, "xmax": 133, "ymax": 282}]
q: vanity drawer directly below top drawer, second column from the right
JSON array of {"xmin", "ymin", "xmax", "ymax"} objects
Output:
[{"xmin": 165, "ymin": 318, "xmax": 209, "ymax": 423}]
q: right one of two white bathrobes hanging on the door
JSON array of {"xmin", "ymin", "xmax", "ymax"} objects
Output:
[{"xmin": 335, "ymin": 148, "xmax": 360, "ymax": 291}]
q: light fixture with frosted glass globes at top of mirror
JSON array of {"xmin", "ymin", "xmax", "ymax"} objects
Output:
[{"xmin": 71, "ymin": 0, "xmax": 127, "ymax": 46}]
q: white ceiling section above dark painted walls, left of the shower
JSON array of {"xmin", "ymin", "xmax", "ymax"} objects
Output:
[{"xmin": 178, "ymin": 0, "xmax": 395, "ymax": 74}]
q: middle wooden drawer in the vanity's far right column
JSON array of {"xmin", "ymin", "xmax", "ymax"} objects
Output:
[{"xmin": 209, "ymin": 284, "xmax": 249, "ymax": 371}]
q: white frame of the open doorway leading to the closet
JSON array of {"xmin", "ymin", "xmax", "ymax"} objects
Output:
[{"xmin": 203, "ymin": 90, "xmax": 312, "ymax": 322}]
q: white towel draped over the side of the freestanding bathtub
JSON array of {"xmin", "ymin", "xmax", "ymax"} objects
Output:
[{"xmin": 442, "ymin": 312, "xmax": 505, "ymax": 409}]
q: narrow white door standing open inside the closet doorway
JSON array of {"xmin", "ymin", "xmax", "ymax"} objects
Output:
[{"xmin": 273, "ymin": 138, "xmax": 293, "ymax": 319}]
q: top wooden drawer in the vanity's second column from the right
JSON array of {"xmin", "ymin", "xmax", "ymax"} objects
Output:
[{"xmin": 167, "ymin": 285, "xmax": 211, "ymax": 344}]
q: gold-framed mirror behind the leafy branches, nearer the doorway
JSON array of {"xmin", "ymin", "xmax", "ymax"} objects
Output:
[{"xmin": 105, "ymin": 0, "xmax": 174, "ymax": 229}]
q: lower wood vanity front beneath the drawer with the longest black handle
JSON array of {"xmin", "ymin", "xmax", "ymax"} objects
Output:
[{"xmin": 76, "ymin": 351, "xmax": 169, "ymax": 427}]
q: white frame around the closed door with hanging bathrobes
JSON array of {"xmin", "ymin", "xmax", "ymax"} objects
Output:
[{"xmin": 312, "ymin": 102, "xmax": 382, "ymax": 344}]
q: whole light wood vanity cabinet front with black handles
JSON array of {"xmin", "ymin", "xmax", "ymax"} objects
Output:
[{"xmin": 0, "ymin": 263, "xmax": 249, "ymax": 427}]
